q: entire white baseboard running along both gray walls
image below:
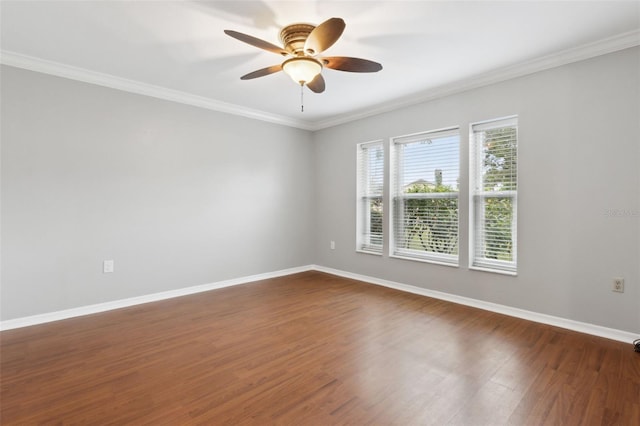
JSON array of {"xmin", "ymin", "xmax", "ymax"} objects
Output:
[{"xmin": 0, "ymin": 265, "xmax": 638, "ymax": 343}]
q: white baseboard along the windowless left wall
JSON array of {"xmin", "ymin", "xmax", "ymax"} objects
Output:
[{"xmin": 0, "ymin": 266, "xmax": 313, "ymax": 331}]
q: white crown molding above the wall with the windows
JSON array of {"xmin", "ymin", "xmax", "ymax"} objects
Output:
[{"xmin": 311, "ymin": 30, "xmax": 640, "ymax": 131}]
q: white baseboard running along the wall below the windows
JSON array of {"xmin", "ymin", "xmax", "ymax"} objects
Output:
[{"xmin": 311, "ymin": 265, "xmax": 638, "ymax": 343}]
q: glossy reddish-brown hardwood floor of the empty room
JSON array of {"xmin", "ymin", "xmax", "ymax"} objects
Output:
[{"xmin": 0, "ymin": 272, "xmax": 640, "ymax": 426}]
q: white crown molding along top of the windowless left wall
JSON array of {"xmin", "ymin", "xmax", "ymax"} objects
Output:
[{"xmin": 0, "ymin": 50, "xmax": 311, "ymax": 130}]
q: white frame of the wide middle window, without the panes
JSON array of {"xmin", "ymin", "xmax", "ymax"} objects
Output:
[{"xmin": 388, "ymin": 126, "xmax": 461, "ymax": 267}]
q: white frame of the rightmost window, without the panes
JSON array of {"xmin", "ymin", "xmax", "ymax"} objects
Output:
[{"xmin": 469, "ymin": 116, "xmax": 519, "ymax": 275}]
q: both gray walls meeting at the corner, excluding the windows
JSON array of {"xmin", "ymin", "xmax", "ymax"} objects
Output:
[{"xmin": 0, "ymin": 48, "xmax": 640, "ymax": 332}]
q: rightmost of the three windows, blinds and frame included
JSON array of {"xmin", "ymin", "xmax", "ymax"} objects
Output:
[{"xmin": 469, "ymin": 117, "xmax": 518, "ymax": 274}]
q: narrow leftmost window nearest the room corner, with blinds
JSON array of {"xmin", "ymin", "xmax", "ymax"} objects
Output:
[{"xmin": 356, "ymin": 141, "xmax": 384, "ymax": 254}]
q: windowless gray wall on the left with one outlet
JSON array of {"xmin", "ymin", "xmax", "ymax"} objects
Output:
[{"xmin": 0, "ymin": 66, "xmax": 314, "ymax": 320}]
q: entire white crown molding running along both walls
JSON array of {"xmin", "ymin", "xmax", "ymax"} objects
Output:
[{"xmin": 0, "ymin": 29, "xmax": 640, "ymax": 131}]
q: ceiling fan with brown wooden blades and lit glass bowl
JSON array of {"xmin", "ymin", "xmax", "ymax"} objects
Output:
[{"xmin": 224, "ymin": 18, "xmax": 382, "ymax": 93}]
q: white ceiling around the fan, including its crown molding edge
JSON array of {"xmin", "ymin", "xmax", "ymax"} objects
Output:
[{"xmin": 0, "ymin": 0, "xmax": 640, "ymax": 129}]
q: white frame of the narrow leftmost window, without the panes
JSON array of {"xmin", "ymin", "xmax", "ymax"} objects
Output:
[{"xmin": 356, "ymin": 140, "xmax": 385, "ymax": 256}]
